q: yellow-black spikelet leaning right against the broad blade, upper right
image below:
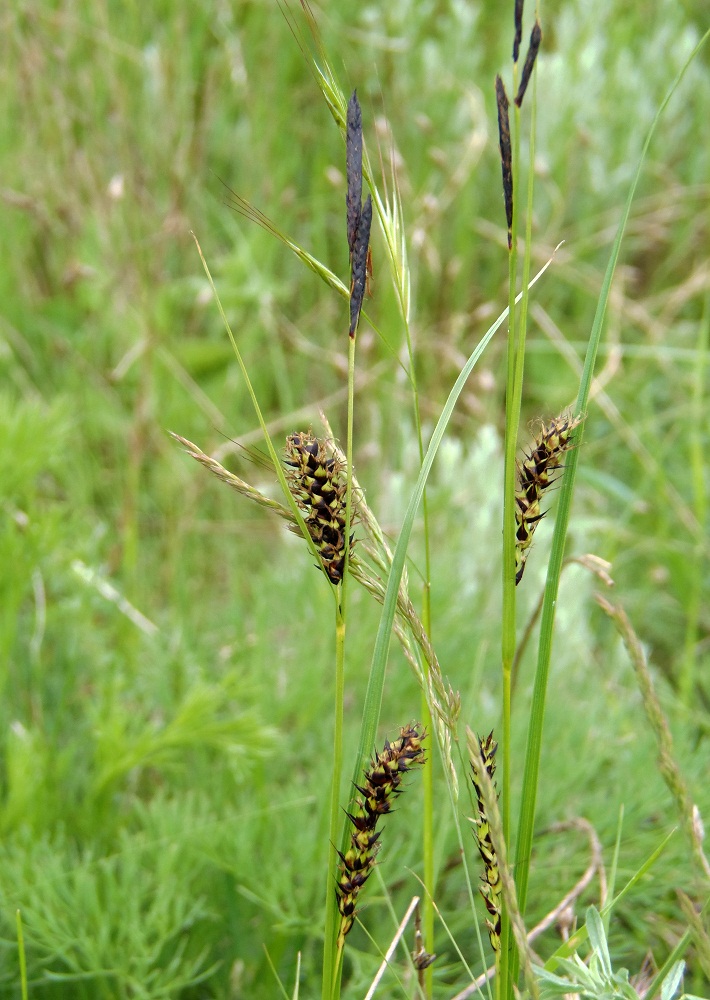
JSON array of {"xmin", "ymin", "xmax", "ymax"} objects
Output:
[{"xmin": 515, "ymin": 414, "xmax": 583, "ymax": 584}]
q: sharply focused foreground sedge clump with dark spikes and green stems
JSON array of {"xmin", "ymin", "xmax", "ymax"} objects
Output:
[{"xmin": 174, "ymin": 0, "xmax": 710, "ymax": 1000}]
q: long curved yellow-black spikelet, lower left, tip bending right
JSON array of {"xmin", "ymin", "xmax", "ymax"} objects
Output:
[{"xmin": 336, "ymin": 723, "xmax": 426, "ymax": 947}]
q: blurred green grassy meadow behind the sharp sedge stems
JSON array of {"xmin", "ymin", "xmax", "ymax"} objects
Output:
[{"xmin": 0, "ymin": 0, "xmax": 710, "ymax": 1000}]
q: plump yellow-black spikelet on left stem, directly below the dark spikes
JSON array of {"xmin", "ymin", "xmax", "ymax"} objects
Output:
[{"xmin": 285, "ymin": 431, "xmax": 352, "ymax": 585}]
